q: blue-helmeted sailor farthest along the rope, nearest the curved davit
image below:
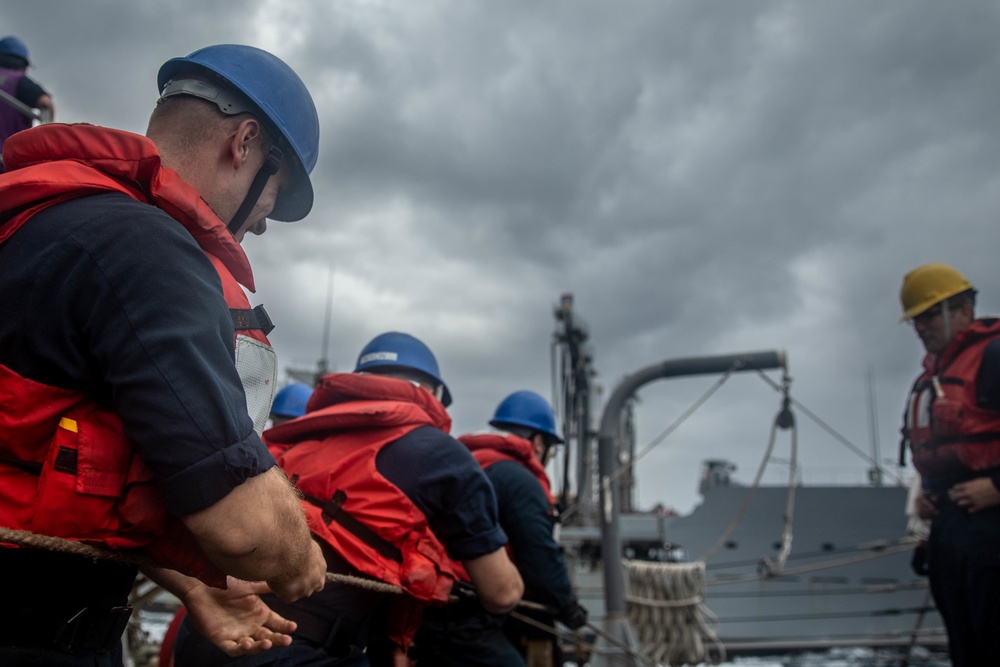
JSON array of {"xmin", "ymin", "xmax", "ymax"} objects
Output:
[{"xmin": 417, "ymin": 391, "xmax": 587, "ymax": 667}]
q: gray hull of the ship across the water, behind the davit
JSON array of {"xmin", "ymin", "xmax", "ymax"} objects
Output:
[{"xmin": 561, "ymin": 485, "xmax": 946, "ymax": 655}]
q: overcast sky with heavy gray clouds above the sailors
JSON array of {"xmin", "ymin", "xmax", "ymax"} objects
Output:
[{"xmin": 0, "ymin": 0, "xmax": 1000, "ymax": 512}]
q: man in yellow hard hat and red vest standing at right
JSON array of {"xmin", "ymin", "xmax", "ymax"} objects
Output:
[{"xmin": 900, "ymin": 264, "xmax": 1000, "ymax": 667}]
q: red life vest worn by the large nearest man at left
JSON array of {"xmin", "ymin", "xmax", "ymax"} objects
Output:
[{"xmin": 0, "ymin": 124, "xmax": 275, "ymax": 587}]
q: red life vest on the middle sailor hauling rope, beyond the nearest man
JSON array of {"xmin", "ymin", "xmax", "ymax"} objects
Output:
[{"xmin": 264, "ymin": 373, "xmax": 455, "ymax": 603}]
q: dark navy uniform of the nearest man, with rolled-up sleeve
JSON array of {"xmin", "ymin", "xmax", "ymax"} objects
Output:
[{"xmin": 0, "ymin": 194, "xmax": 274, "ymax": 666}]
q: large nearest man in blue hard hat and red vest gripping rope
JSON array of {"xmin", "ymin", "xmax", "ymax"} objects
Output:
[{"xmin": 0, "ymin": 44, "xmax": 326, "ymax": 667}]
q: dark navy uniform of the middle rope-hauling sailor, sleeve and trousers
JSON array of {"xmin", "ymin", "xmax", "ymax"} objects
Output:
[{"xmin": 174, "ymin": 426, "xmax": 507, "ymax": 667}]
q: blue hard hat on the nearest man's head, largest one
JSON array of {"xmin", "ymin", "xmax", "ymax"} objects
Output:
[{"xmin": 156, "ymin": 44, "xmax": 319, "ymax": 222}]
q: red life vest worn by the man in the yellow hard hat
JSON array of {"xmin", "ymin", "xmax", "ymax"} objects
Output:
[{"xmin": 903, "ymin": 319, "xmax": 1000, "ymax": 478}]
